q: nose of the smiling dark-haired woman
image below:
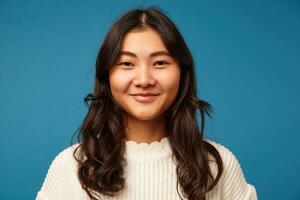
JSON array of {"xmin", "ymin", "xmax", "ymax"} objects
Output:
[{"xmin": 133, "ymin": 65, "xmax": 155, "ymax": 87}]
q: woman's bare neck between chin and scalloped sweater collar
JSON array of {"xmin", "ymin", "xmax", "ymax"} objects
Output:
[{"xmin": 125, "ymin": 114, "xmax": 167, "ymax": 144}]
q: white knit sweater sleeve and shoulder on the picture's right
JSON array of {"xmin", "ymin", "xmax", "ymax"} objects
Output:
[{"xmin": 207, "ymin": 142, "xmax": 257, "ymax": 200}]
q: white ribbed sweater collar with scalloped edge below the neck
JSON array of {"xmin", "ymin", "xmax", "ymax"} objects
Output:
[{"xmin": 125, "ymin": 137, "xmax": 172, "ymax": 162}]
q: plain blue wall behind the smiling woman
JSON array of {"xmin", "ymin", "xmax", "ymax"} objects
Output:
[{"xmin": 0, "ymin": 0, "xmax": 300, "ymax": 200}]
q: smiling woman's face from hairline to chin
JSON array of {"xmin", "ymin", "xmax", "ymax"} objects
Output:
[{"xmin": 109, "ymin": 28, "xmax": 180, "ymax": 120}]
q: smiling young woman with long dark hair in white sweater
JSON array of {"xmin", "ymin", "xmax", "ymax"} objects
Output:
[{"xmin": 36, "ymin": 7, "xmax": 257, "ymax": 200}]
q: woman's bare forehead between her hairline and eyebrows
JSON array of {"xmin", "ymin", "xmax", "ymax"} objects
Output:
[{"xmin": 121, "ymin": 27, "xmax": 168, "ymax": 54}]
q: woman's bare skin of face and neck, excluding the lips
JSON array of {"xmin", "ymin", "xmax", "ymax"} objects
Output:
[{"xmin": 109, "ymin": 27, "xmax": 180, "ymax": 143}]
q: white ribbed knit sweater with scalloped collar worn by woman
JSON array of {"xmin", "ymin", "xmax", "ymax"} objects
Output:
[{"xmin": 36, "ymin": 137, "xmax": 257, "ymax": 200}]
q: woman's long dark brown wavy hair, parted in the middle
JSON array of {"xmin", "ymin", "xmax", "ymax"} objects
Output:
[{"xmin": 72, "ymin": 7, "xmax": 223, "ymax": 200}]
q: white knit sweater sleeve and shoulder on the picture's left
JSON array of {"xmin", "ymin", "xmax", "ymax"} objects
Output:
[{"xmin": 36, "ymin": 147, "xmax": 78, "ymax": 200}]
